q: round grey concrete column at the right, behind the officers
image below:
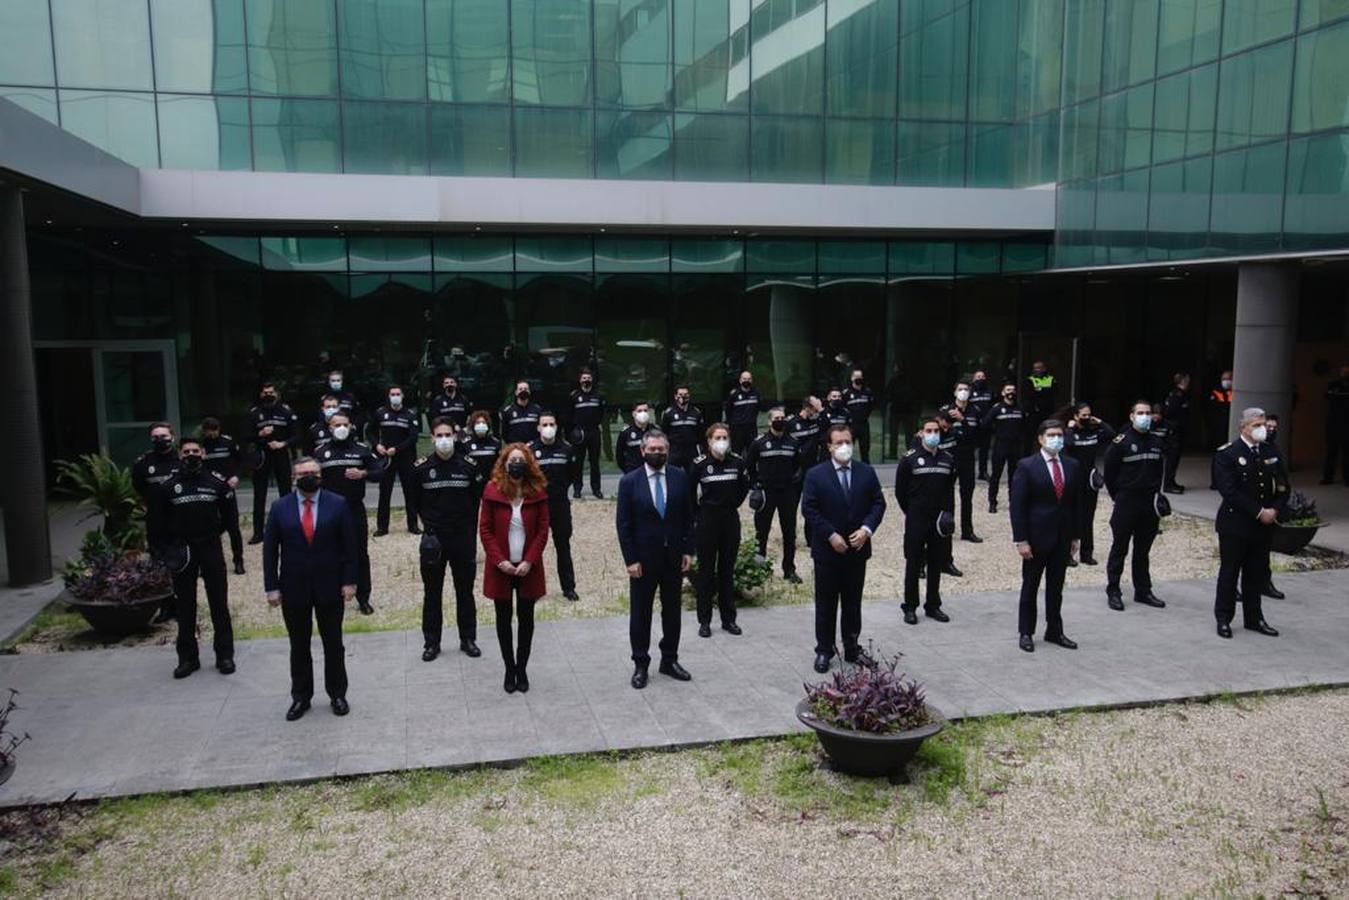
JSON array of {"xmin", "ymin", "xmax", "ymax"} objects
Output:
[{"xmin": 1228, "ymin": 263, "xmax": 1299, "ymax": 439}]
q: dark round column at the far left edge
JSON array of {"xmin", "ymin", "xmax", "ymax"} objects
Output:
[{"xmin": 0, "ymin": 182, "xmax": 51, "ymax": 587}]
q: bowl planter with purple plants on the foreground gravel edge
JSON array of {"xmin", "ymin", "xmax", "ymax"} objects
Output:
[{"xmin": 796, "ymin": 653, "xmax": 946, "ymax": 779}]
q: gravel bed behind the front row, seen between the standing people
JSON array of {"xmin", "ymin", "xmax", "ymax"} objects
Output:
[{"xmin": 18, "ymin": 483, "xmax": 1325, "ymax": 653}]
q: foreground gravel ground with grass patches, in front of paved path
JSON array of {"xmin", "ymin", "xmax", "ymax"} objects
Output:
[{"xmin": 0, "ymin": 691, "xmax": 1349, "ymax": 897}]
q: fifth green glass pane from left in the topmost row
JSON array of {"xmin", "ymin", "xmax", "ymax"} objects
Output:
[{"xmin": 337, "ymin": 0, "xmax": 426, "ymax": 100}]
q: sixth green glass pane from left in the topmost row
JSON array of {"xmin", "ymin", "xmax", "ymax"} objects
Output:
[{"xmin": 426, "ymin": 0, "xmax": 510, "ymax": 103}]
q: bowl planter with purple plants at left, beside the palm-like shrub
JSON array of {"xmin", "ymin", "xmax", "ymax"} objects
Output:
[{"xmin": 62, "ymin": 530, "xmax": 173, "ymax": 637}]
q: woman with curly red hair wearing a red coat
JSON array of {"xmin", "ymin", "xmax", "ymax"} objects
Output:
[{"xmin": 478, "ymin": 444, "xmax": 548, "ymax": 694}]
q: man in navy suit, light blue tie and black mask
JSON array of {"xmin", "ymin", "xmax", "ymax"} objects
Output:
[{"xmin": 616, "ymin": 428, "xmax": 693, "ymax": 691}]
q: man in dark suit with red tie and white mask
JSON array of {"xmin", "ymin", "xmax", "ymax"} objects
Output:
[{"xmin": 1009, "ymin": 418, "xmax": 1082, "ymax": 653}]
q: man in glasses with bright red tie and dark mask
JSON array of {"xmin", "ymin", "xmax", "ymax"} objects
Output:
[{"xmin": 262, "ymin": 456, "xmax": 360, "ymax": 722}]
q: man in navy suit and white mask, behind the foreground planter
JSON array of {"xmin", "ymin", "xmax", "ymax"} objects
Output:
[{"xmin": 801, "ymin": 425, "xmax": 885, "ymax": 672}]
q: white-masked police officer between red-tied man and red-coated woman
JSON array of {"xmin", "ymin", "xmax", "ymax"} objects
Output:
[{"xmin": 413, "ymin": 416, "xmax": 484, "ymax": 663}]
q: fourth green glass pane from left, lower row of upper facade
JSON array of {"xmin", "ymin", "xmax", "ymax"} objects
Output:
[{"xmin": 251, "ymin": 97, "xmax": 341, "ymax": 171}]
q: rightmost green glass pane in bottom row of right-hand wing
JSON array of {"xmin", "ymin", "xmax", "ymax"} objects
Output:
[{"xmin": 1283, "ymin": 131, "xmax": 1349, "ymax": 248}]
